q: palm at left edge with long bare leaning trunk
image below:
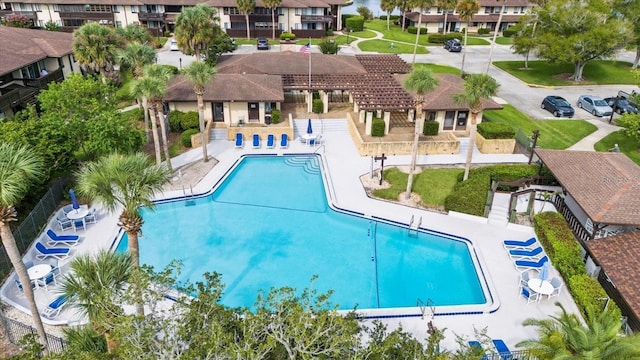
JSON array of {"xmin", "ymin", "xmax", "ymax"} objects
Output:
[{"xmin": 0, "ymin": 142, "xmax": 47, "ymax": 349}]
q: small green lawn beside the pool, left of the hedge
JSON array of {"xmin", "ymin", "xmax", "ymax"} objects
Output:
[{"xmin": 373, "ymin": 168, "xmax": 464, "ymax": 207}]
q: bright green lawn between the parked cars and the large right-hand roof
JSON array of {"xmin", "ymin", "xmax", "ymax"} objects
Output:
[{"xmin": 483, "ymin": 104, "xmax": 597, "ymax": 150}]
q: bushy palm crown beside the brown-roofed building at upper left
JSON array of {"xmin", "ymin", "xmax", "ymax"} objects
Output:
[{"xmin": 73, "ymin": 22, "xmax": 122, "ymax": 81}]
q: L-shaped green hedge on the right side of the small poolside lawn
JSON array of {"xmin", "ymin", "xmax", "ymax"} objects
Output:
[{"xmin": 444, "ymin": 165, "xmax": 538, "ymax": 216}]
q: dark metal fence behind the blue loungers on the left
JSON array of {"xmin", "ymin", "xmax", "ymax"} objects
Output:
[{"xmin": 0, "ymin": 178, "xmax": 67, "ymax": 279}]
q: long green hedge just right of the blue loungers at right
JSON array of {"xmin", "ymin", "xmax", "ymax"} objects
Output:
[{"xmin": 533, "ymin": 211, "xmax": 622, "ymax": 317}]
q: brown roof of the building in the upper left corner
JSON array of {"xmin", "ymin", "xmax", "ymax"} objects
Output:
[{"xmin": 0, "ymin": 26, "xmax": 73, "ymax": 74}]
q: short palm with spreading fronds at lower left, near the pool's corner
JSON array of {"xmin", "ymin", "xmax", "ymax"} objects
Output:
[{"xmin": 61, "ymin": 250, "xmax": 131, "ymax": 353}]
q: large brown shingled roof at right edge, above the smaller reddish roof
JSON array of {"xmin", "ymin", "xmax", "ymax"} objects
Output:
[{"xmin": 535, "ymin": 149, "xmax": 640, "ymax": 226}]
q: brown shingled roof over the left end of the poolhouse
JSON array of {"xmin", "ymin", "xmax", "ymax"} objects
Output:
[{"xmin": 164, "ymin": 74, "xmax": 284, "ymax": 102}]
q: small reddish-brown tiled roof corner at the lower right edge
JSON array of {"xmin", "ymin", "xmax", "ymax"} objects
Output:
[{"xmin": 585, "ymin": 231, "xmax": 640, "ymax": 324}]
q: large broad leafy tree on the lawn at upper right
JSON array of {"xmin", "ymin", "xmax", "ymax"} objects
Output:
[{"xmin": 535, "ymin": 0, "xmax": 632, "ymax": 81}]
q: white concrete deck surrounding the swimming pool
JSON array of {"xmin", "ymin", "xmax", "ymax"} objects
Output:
[{"xmin": 0, "ymin": 120, "xmax": 578, "ymax": 350}]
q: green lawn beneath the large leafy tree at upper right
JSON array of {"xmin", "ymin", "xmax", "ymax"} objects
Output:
[{"xmin": 493, "ymin": 60, "xmax": 637, "ymax": 86}]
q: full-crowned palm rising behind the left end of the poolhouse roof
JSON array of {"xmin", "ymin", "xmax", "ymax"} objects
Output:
[{"xmin": 175, "ymin": 3, "xmax": 220, "ymax": 61}]
